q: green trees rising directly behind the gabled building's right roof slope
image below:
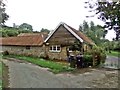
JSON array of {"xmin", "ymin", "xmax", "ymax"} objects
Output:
[{"xmin": 79, "ymin": 21, "xmax": 107, "ymax": 45}]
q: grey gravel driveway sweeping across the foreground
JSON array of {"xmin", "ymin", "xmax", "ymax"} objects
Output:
[{"xmin": 3, "ymin": 59, "xmax": 118, "ymax": 88}]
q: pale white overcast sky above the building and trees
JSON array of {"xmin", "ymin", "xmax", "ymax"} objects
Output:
[{"xmin": 6, "ymin": 0, "xmax": 115, "ymax": 40}]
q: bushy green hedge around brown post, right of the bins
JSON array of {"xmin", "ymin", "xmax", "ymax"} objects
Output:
[{"xmin": 83, "ymin": 46, "xmax": 106, "ymax": 66}]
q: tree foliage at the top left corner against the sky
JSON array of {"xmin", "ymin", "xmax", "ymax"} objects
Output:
[{"xmin": 0, "ymin": 0, "xmax": 9, "ymax": 26}]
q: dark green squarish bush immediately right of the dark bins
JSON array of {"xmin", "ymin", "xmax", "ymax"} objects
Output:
[{"xmin": 83, "ymin": 55, "xmax": 93, "ymax": 67}]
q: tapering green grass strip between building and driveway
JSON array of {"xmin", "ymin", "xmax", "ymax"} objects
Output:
[{"xmin": 3, "ymin": 55, "xmax": 73, "ymax": 73}]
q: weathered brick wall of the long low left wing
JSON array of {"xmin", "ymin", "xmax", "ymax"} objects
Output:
[{"xmin": 2, "ymin": 46, "xmax": 45, "ymax": 57}]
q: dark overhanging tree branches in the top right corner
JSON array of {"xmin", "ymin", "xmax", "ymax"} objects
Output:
[{"xmin": 85, "ymin": 0, "xmax": 120, "ymax": 40}]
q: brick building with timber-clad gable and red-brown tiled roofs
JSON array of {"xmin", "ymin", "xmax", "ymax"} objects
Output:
[{"xmin": 0, "ymin": 23, "xmax": 95, "ymax": 60}]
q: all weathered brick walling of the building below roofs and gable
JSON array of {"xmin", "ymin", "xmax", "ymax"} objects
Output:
[{"xmin": 0, "ymin": 45, "xmax": 90, "ymax": 60}]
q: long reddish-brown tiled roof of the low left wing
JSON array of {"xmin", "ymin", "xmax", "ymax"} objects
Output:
[{"xmin": 0, "ymin": 33, "xmax": 47, "ymax": 46}]
